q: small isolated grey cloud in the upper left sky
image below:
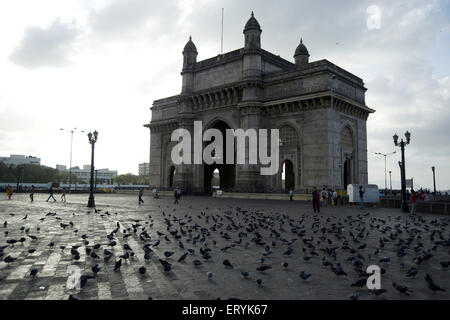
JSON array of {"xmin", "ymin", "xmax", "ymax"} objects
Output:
[{"xmin": 10, "ymin": 20, "xmax": 79, "ymax": 69}]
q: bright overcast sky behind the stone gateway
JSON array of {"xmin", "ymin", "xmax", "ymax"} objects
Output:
[{"xmin": 0, "ymin": 0, "xmax": 450, "ymax": 189}]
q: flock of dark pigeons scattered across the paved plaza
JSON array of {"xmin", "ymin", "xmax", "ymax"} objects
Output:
[{"xmin": 0, "ymin": 200, "xmax": 450, "ymax": 300}]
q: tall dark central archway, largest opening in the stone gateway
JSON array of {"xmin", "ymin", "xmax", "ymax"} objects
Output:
[{"xmin": 204, "ymin": 120, "xmax": 236, "ymax": 193}]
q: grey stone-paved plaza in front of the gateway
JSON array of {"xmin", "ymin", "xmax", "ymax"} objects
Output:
[{"xmin": 0, "ymin": 194, "xmax": 450, "ymax": 300}]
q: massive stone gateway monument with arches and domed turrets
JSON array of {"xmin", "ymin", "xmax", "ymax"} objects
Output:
[{"xmin": 145, "ymin": 12, "xmax": 374, "ymax": 194}]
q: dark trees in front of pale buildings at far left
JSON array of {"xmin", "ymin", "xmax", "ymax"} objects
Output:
[{"xmin": 0, "ymin": 162, "xmax": 77, "ymax": 183}]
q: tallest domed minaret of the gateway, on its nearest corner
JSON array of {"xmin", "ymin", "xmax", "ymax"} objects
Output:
[{"xmin": 244, "ymin": 11, "xmax": 262, "ymax": 80}]
